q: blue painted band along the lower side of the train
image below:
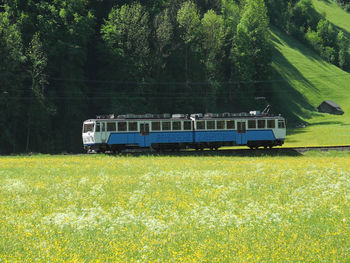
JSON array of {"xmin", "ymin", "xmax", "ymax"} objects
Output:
[{"xmin": 107, "ymin": 130, "xmax": 276, "ymax": 147}]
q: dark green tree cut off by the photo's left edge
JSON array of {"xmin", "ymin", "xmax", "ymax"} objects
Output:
[{"xmin": 0, "ymin": 11, "xmax": 26, "ymax": 153}]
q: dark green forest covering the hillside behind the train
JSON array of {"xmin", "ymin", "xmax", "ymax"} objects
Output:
[{"xmin": 0, "ymin": 0, "xmax": 350, "ymax": 154}]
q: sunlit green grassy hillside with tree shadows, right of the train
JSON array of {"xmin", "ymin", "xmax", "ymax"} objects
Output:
[{"xmin": 271, "ymin": 1, "xmax": 350, "ymax": 146}]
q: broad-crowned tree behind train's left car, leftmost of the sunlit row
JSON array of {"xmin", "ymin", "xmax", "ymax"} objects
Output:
[{"xmin": 101, "ymin": 3, "xmax": 152, "ymax": 112}]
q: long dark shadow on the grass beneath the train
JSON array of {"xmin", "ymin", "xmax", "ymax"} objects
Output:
[{"xmin": 111, "ymin": 148, "xmax": 302, "ymax": 157}]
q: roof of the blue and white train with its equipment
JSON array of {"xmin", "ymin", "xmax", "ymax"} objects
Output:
[{"xmin": 87, "ymin": 111, "xmax": 284, "ymax": 121}]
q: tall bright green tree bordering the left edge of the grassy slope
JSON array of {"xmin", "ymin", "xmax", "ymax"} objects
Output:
[{"xmin": 231, "ymin": 0, "xmax": 271, "ymax": 108}]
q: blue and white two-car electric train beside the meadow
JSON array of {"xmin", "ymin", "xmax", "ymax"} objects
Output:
[{"xmin": 82, "ymin": 111, "xmax": 286, "ymax": 153}]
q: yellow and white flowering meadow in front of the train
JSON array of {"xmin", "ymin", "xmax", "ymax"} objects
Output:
[{"xmin": 0, "ymin": 154, "xmax": 350, "ymax": 262}]
